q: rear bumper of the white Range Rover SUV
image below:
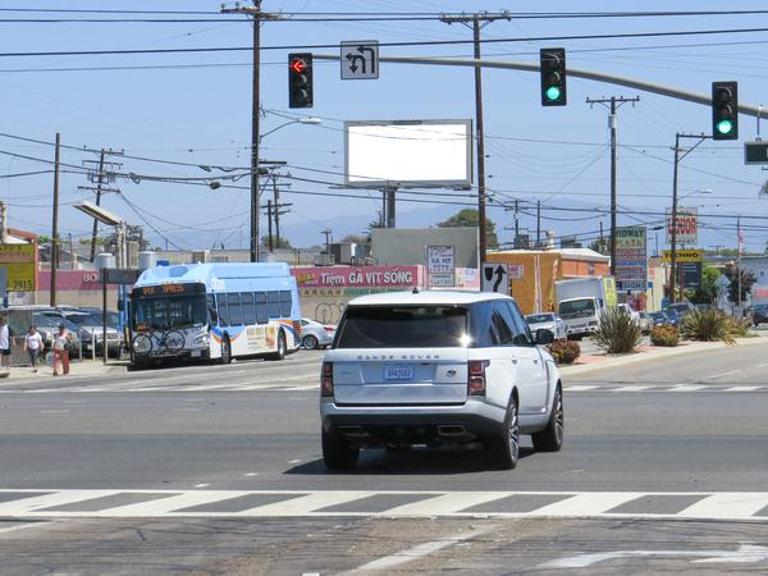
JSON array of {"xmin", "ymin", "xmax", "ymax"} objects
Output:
[{"xmin": 320, "ymin": 400, "xmax": 506, "ymax": 446}]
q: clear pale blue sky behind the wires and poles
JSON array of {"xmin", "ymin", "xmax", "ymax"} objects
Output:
[{"xmin": 0, "ymin": 0, "xmax": 768, "ymax": 251}]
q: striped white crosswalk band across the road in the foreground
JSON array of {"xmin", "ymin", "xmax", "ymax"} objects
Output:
[{"xmin": 0, "ymin": 489, "xmax": 768, "ymax": 522}]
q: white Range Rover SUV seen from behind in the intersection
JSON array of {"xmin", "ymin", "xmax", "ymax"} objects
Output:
[{"xmin": 320, "ymin": 291, "xmax": 564, "ymax": 470}]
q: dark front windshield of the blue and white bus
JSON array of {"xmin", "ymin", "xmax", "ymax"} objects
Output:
[{"xmin": 131, "ymin": 294, "xmax": 208, "ymax": 331}]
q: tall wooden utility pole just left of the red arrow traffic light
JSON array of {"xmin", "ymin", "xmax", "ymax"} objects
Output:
[{"xmin": 221, "ymin": 0, "xmax": 277, "ymax": 262}]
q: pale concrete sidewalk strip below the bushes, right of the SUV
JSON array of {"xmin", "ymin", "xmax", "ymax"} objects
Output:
[{"xmin": 558, "ymin": 335, "xmax": 768, "ymax": 376}]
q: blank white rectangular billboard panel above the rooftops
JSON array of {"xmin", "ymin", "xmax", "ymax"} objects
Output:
[{"xmin": 344, "ymin": 120, "xmax": 472, "ymax": 188}]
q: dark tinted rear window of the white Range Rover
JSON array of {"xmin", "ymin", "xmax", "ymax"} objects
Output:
[{"xmin": 336, "ymin": 306, "xmax": 467, "ymax": 348}]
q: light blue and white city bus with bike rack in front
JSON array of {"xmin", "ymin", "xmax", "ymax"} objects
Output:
[{"xmin": 129, "ymin": 263, "xmax": 301, "ymax": 368}]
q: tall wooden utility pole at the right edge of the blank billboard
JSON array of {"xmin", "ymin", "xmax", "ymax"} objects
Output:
[{"xmin": 440, "ymin": 10, "xmax": 511, "ymax": 263}]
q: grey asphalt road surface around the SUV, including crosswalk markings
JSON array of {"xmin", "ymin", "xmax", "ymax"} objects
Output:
[{"xmin": 0, "ymin": 345, "xmax": 768, "ymax": 576}]
